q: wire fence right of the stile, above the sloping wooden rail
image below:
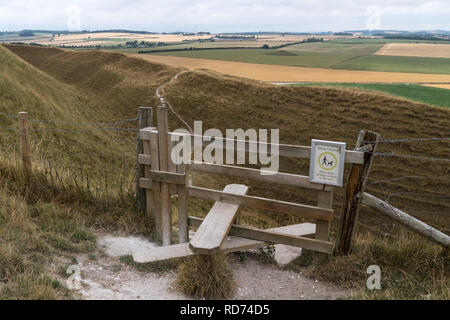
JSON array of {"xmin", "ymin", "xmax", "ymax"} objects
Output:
[{"xmin": 360, "ymin": 137, "xmax": 450, "ymax": 236}]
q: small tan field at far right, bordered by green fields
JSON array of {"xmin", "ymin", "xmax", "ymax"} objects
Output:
[{"xmin": 375, "ymin": 43, "xmax": 450, "ymax": 58}]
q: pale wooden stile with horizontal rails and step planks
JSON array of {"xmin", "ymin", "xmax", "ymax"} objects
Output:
[{"xmin": 135, "ymin": 107, "xmax": 364, "ymax": 262}]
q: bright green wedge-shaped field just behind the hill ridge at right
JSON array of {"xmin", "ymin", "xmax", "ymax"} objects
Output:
[{"xmin": 294, "ymin": 83, "xmax": 450, "ymax": 108}]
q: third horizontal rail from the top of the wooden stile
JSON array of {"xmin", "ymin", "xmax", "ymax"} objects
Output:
[{"xmin": 188, "ymin": 186, "xmax": 333, "ymax": 221}]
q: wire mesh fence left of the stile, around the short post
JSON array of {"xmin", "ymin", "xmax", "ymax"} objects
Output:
[{"xmin": 0, "ymin": 112, "xmax": 139, "ymax": 204}]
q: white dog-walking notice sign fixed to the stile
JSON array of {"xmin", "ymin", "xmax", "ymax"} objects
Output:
[{"xmin": 309, "ymin": 139, "xmax": 346, "ymax": 187}]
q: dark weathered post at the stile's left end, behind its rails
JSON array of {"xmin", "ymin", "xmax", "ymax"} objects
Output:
[{"xmin": 136, "ymin": 107, "xmax": 153, "ymax": 213}]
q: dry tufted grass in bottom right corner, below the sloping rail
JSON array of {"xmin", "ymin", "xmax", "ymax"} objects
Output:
[{"xmin": 287, "ymin": 230, "xmax": 450, "ymax": 300}]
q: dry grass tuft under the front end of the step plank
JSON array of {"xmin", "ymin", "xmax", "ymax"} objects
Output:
[{"xmin": 176, "ymin": 253, "xmax": 236, "ymax": 299}]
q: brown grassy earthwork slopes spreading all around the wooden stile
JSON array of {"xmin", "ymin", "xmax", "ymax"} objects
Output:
[{"xmin": 0, "ymin": 46, "xmax": 450, "ymax": 298}]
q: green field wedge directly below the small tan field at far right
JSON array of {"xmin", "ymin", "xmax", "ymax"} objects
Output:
[{"xmin": 333, "ymin": 55, "xmax": 450, "ymax": 74}]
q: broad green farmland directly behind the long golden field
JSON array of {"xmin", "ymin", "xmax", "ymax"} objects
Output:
[{"xmin": 145, "ymin": 39, "xmax": 450, "ymax": 74}]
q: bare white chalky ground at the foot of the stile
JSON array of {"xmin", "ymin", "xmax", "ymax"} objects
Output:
[{"xmin": 70, "ymin": 234, "xmax": 350, "ymax": 300}]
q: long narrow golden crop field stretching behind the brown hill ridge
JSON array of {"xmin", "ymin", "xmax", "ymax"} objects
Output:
[{"xmin": 131, "ymin": 54, "xmax": 450, "ymax": 83}]
